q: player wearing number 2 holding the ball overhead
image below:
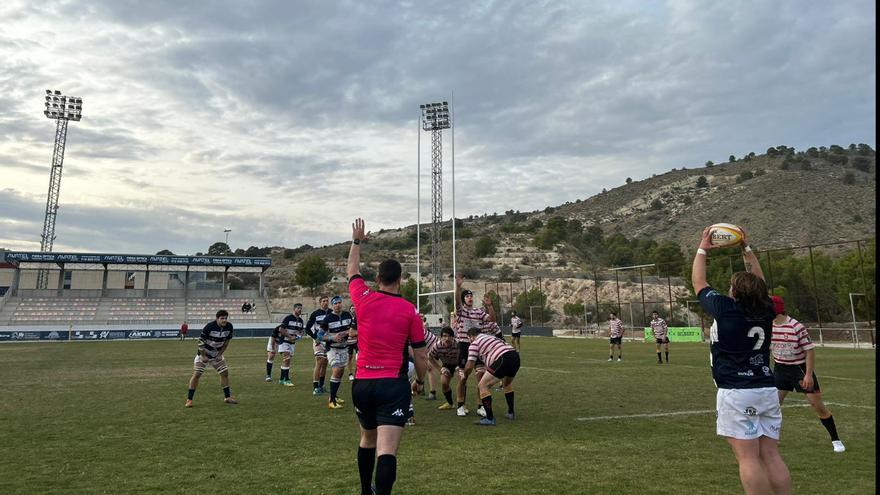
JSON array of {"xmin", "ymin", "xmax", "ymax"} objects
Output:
[{"xmin": 691, "ymin": 228, "xmax": 791, "ymax": 494}]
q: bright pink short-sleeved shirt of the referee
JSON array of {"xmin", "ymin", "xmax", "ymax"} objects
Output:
[{"xmin": 348, "ymin": 275, "xmax": 425, "ymax": 380}]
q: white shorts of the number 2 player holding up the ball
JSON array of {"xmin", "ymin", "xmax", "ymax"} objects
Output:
[{"xmin": 715, "ymin": 387, "xmax": 782, "ymax": 440}]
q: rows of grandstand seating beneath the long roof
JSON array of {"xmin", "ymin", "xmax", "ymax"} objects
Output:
[{"xmin": 0, "ymin": 297, "xmax": 270, "ymax": 325}]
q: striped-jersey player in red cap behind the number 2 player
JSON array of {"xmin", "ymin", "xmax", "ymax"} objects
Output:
[{"xmin": 770, "ymin": 296, "xmax": 846, "ymax": 452}]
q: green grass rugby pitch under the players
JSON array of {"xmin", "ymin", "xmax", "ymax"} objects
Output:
[{"xmin": 0, "ymin": 338, "xmax": 876, "ymax": 495}]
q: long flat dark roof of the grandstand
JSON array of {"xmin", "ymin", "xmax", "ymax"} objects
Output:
[{"xmin": 0, "ymin": 251, "xmax": 272, "ymax": 272}]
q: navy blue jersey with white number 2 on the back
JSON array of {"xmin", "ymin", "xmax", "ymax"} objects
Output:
[{"xmin": 697, "ymin": 287, "xmax": 775, "ymax": 388}]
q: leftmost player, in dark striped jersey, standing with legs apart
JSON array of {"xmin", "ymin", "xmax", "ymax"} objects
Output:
[{"xmin": 185, "ymin": 309, "xmax": 238, "ymax": 407}]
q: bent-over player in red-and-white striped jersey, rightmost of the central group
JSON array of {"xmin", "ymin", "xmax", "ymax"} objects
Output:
[{"xmin": 464, "ymin": 328, "xmax": 519, "ymax": 426}]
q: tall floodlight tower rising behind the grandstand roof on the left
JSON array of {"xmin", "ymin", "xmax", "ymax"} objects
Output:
[{"xmin": 37, "ymin": 89, "xmax": 82, "ymax": 289}]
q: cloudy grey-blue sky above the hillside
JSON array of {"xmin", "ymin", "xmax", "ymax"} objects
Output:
[{"xmin": 0, "ymin": 0, "xmax": 876, "ymax": 254}]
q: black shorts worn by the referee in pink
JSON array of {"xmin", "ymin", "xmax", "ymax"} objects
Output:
[{"xmin": 351, "ymin": 377, "xmax": 411, "ymax": 430}]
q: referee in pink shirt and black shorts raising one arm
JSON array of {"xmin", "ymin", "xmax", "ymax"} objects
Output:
[{"xmin": 347, "ymin": 218, "xmax": 427, "ymax": 495}]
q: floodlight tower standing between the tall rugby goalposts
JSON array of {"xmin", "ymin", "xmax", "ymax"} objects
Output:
[{"xmin": 420, "ymin": 101, "xmax": 450, "ymax": 311}]
